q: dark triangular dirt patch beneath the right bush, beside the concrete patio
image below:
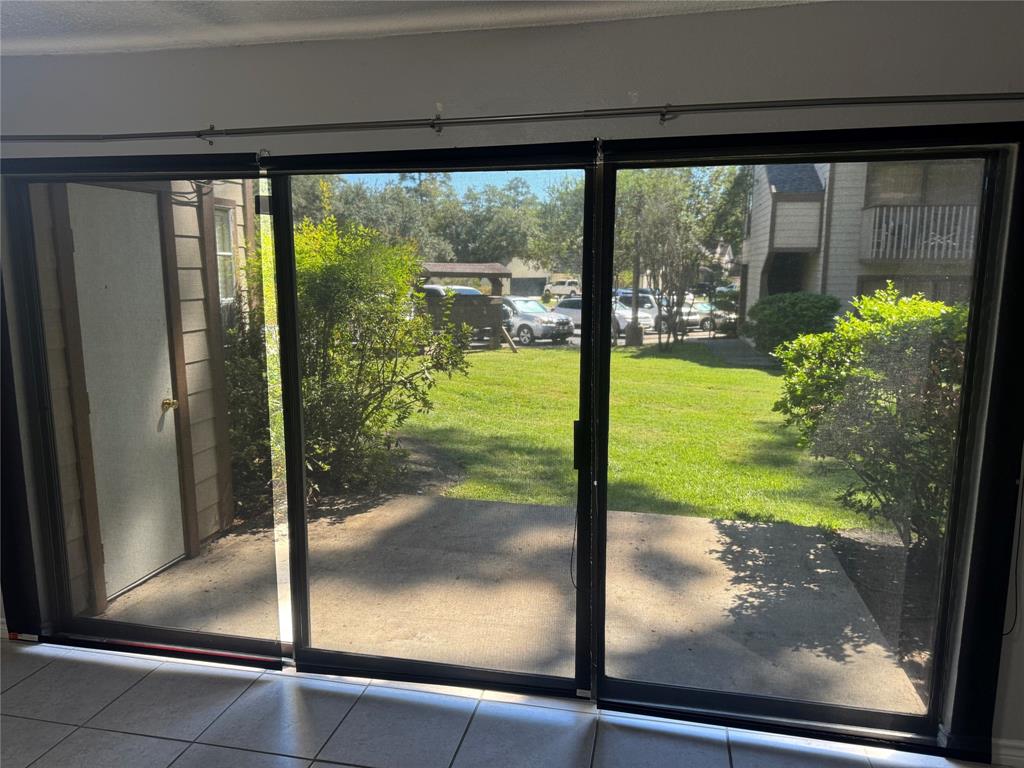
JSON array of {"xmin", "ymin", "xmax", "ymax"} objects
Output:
[{"xmin": 829, "ymin": 529, "xmax": 938, "ymax": 700}]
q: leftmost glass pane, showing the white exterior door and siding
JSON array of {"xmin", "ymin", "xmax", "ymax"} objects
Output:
[{"xmin": 31, "ymin": 179, "xmax": 281, "ymax": 639}]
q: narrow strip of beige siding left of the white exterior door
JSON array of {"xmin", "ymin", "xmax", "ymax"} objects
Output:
[{"xmin": 30, "ymin": 184, "xmax": 91, "ymax": 613}]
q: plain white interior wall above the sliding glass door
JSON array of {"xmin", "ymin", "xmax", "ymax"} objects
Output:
[{"xmin": 0, "ymin": 2, "xmax": 1024, "ymax": 157}]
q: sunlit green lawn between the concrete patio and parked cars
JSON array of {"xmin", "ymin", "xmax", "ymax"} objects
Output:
[{"xmin": 403, "ymin": 344, "xmax": 870, "ymax": 528}]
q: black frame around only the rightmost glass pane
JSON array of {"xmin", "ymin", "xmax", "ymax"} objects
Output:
[{"xmin": 593, "ymin": 127, "xmax": 1022, "ymax": 760}]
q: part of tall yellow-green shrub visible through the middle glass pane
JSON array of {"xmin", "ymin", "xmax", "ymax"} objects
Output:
[{"xmin": 295, "ymin": 211, "xmax": 468, "ymax": 499}]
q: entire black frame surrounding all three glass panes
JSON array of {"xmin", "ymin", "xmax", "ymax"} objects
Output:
[{"xmin": 3, "ymin": 123, "xmax": 1024, "ymax": 759}]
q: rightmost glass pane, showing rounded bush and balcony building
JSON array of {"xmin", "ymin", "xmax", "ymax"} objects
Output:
[{"xmin": 605, "ymin": 160, "xmax": 983, "ymax": 714}]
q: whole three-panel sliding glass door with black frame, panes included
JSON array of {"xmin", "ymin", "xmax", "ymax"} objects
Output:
[{"xmin": 8, "ymin": 126, "xmax": 1019, "ymax": 749}]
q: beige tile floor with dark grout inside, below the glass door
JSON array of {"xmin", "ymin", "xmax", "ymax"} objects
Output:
[{"xmin": 0, "ymin": 640, "xmax": 987, "ymax": 768}]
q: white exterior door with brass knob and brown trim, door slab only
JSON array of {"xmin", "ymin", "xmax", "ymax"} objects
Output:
[{"xmin": 68, "ymin": 184, "xmax": 184, "ymax": 596}]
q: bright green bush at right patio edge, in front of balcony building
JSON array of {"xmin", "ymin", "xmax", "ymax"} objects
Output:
[{"xmin": 775, "ymin": 284, "xmax": 968, "ymax": 561}]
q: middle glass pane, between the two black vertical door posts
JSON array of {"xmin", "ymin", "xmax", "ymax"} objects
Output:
[{"xmin": 293, "ymin": 171, "xmax": 583, "ymax": 677}]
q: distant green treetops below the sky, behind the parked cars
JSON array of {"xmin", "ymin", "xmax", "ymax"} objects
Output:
[{"xmin": 292, "ymin": 166, "xmax": 752, "ymax": 282}]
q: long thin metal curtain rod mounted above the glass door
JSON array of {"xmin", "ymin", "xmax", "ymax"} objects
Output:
[{"xmin": 0, "ymin": 92, "xmax": 1024, "ymax": 144}]
